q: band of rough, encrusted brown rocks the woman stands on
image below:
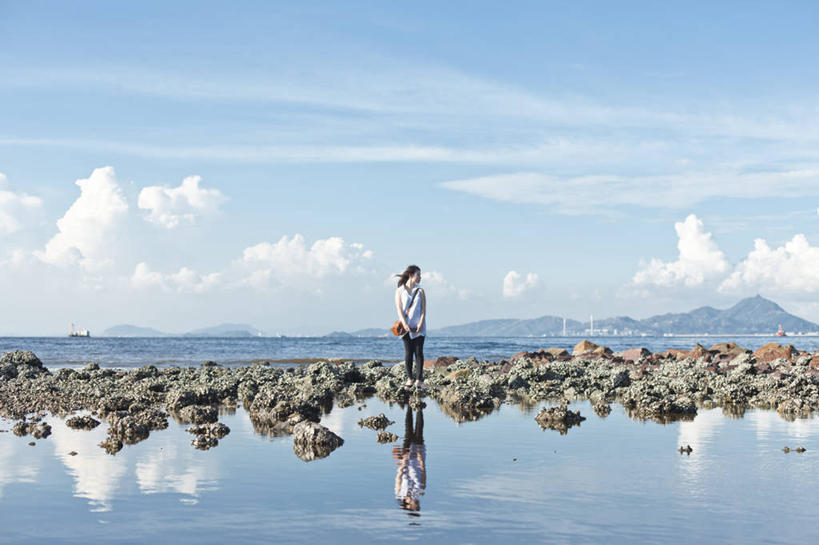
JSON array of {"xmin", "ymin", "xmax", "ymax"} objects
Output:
[{"xmin": 0, "ymin": 341, "xmax": 819, "ymax": 460}]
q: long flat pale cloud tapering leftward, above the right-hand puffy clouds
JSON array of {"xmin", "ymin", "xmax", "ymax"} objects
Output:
[{"xmin": 441, "ymin": 168, "xmax": 819, "ymax": 214}]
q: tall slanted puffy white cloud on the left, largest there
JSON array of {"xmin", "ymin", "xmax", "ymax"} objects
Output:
[{"xmin": 36, "ymin": 167, "xmax": 128, "ymax": 271}]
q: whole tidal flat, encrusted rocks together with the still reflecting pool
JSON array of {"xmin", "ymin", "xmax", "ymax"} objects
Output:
[{"xmin": 0, "ymin": 343, "xmax": 819, "ymax": 543}]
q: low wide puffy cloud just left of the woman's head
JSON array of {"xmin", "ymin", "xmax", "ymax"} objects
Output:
[{"xmin": 242, "ymin": 234, "xmax": 373, "ymax": 287}]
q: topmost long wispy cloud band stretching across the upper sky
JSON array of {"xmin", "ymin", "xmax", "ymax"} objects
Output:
[{"xmin": 4, "ymin": 60, "xmax": 819, "ymax": 141}]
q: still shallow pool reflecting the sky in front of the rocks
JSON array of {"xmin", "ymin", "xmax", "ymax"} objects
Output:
[{"xmin": 0, "ymin": 398, "xmax": 819, "ymax": 544}]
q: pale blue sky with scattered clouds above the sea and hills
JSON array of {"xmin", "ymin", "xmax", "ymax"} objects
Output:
[{"xmin": 0, "ymin": 0, "xmax": 819, "ymax": 335}]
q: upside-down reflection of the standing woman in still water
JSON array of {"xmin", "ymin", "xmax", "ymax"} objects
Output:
[{"xmin": 392, "ymin": 405, "xmax": 427, "ymax": 517}]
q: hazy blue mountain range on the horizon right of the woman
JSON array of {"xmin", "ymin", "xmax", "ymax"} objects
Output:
[{"xmin": 338, "ymin": 295, "xmax": 819, "ymax": 337}]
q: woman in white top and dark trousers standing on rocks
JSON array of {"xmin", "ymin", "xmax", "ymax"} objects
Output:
[{"xmin": 395, "ymin": 265, "xmax": 427, "ymax": 388}]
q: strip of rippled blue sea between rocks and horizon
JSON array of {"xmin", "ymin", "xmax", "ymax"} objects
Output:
[{"xmin": 0, "ymin": 336, "xmax": 819, "ymax": 367}]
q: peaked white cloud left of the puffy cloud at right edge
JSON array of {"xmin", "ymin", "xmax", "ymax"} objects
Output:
[{"xmin": 632, "ymin": 214, "xmax": 730, "ymax": 287}]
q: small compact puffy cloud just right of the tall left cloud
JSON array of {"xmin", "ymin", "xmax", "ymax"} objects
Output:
[{"xmin": 137, "ymin": 176, "xmax": 226, "ymax": 229}]
